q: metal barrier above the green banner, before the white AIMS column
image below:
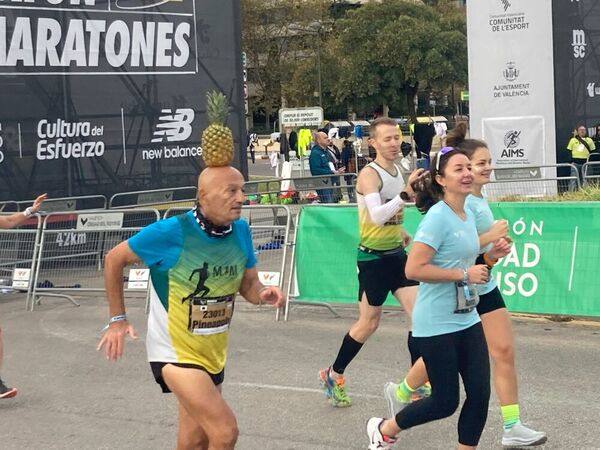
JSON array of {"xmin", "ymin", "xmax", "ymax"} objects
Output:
[{"xmin": 485, "ymin": 164, "xmax": 581, "ymax": 201}]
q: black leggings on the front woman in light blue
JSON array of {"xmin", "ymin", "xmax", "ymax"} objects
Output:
[{"xmin": 396, "ymin": 323, "xmax": 490, "ymax": 446}]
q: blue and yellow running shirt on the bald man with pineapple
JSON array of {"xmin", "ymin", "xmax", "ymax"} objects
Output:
[{"xmin": 127, "ymin": 211, "xmax": 256, "ymax": 374}]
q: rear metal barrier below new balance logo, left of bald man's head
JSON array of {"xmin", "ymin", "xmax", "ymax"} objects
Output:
[{"xmin": 108, "ymin": 186, "xmax": 197, "ymax": 210}]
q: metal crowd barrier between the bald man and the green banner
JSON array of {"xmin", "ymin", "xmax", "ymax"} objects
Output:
[{"xmin": 164, "ymin": 205, "xmax": 292, "ymax": 320}]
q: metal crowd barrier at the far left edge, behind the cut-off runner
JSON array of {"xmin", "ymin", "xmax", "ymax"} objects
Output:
[{"xmin": 0, "ymin": 214, "xmax": 42, "ymax": 309}]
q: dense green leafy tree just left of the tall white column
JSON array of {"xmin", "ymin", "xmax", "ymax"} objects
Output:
[{"xmin": 331, "ymin": 0, "xmax": 467, "ymax": 116}]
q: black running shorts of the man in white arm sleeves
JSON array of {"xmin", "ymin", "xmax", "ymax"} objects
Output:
[{"xmin": 357, "ymin": 250, "xmax": 419, "ymax": 306}]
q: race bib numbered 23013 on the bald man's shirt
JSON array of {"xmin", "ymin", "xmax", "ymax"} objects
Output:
[{"xmin": 188, "ymin": 295, "xmax": 235, "ymax": 336}]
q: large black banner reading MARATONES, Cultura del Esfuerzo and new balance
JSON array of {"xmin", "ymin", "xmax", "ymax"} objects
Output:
[{"xmin": 0, "ymin": 0, "xmax": 247, "ymax": 200}]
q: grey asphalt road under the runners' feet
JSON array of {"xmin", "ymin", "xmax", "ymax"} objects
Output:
[{"xmin": 0, "ymin": 295, "xmax": 600, "ymax": 450}]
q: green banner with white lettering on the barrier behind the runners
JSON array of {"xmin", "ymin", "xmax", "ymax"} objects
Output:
[{"xmin": 296, "ymin": 202, "xmax": 600, "ymax": 317}]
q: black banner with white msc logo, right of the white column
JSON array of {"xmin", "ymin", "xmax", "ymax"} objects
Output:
[{"xmin": 552, "ymin": 0, "xmax": 600, "ymax": 162}]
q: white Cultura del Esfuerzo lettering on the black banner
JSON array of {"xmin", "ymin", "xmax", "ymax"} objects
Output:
[{"xmin": 36, "ymin": 119, "xmax": 104, "ymax": 160}]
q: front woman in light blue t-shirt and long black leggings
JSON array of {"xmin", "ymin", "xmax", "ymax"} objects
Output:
[{"xmin": 367, "ymin": 147, "xmax": 509, "ymax": 449}]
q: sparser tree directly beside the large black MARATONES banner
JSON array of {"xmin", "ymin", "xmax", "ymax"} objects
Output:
[{"xmin": 242, "ymin": 0, "xmax": 331, "ymax": 128}]
